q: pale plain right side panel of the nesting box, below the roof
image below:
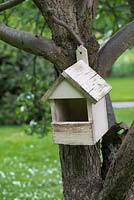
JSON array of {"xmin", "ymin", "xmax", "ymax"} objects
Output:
[{"xmin": 92, "ymin": 97, "xmax": 108, "ymax": 143}]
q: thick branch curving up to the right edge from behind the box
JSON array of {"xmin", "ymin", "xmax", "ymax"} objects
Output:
[{"xmin": 97, "ymin": 21, "xmax": 134, "ymax": 76}]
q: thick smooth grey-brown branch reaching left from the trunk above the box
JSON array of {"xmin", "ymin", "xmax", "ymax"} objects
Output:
[{"xmin": 0, "ymin": 24, "xmax": 72, "ymax": 70}]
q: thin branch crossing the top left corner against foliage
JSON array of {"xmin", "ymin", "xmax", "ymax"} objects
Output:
[{"xmin": 0, "ymin": 0, "xmax": 25, "ymax": 12}]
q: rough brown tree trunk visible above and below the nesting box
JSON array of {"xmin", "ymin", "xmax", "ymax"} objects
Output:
[{"xmin": 35, "ymin": 0, "xmax": 102, "ymax": 200}]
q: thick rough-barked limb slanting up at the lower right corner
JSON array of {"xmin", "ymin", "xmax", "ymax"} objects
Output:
[{"xmin": 98, "ymin": 123, "xmax": 134, "ymax": 200}]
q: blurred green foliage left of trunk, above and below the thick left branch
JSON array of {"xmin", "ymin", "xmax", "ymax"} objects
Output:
[{"xmin": 0, "ymin": 0, "xmax": 55, "ymax": 134}]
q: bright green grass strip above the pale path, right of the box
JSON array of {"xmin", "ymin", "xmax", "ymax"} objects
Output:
[{"xmin": 107, "ymin": 78, "xmax": 134, "ymax": 101}]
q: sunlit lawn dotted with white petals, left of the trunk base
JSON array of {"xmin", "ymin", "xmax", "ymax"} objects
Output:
[{"xmin": 0, "ymin": 127, "xmax": 63, "ymax": 200}]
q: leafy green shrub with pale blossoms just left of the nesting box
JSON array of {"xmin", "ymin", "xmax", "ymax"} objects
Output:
[{"xmin": 16, "ymin": 57, "xmax": 55, "ymax": 135}]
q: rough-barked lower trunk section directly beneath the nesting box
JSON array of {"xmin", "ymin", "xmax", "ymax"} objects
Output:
[{"xmin": 60, "ymin": 145, "xmax": 102, "ymax": 200}]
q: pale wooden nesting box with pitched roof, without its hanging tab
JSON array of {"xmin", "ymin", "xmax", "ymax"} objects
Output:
[{"xmin": 43, "ymin": 60, "xmax": 111, "ymax": 145}]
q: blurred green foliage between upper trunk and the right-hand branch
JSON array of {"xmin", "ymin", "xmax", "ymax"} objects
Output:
[{"xmin": 93, "ymin": 0, "xmax": 131, "ymax": 42}]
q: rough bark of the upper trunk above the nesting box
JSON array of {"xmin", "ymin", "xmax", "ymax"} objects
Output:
[{"xmin": 34, "ymin": 0, "xmax": 99, "ymax": 67}]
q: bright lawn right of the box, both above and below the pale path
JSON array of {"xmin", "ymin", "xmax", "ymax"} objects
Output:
[{"xmin": 107, "ymin": 78, "xmax": 134, "ymax": 126}]
